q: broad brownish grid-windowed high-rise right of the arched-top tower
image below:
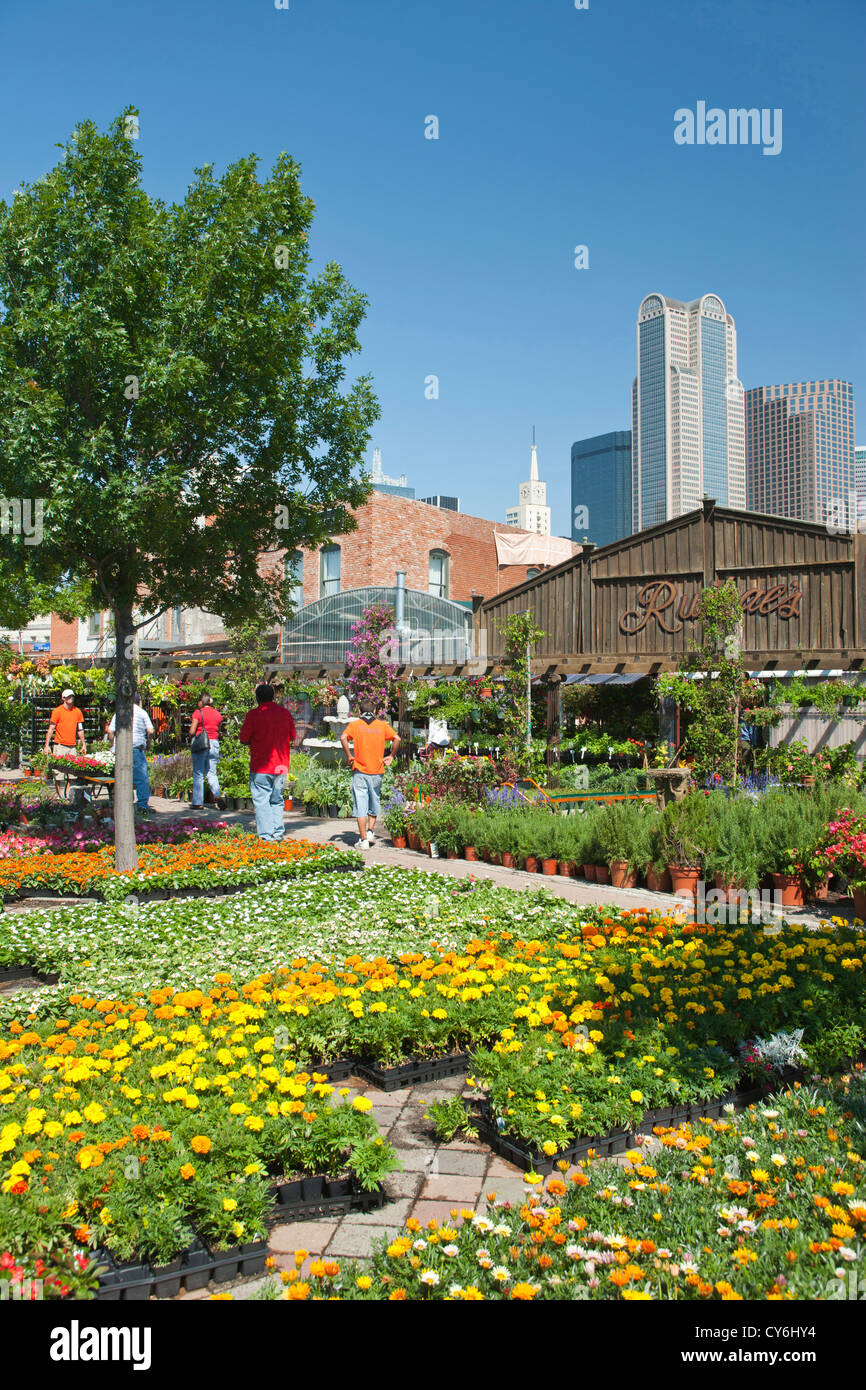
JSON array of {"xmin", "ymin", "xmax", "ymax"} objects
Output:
[{"xmin": 745, "ymin": 379, "xmax": 858, "ymax": 524}]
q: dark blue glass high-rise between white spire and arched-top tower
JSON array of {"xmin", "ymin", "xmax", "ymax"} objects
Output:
[{"xmin": 571, "ymin": 430, "xmax": 632, "ymax": 545}]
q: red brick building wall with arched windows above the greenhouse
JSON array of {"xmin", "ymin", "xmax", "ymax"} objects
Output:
[{"xmin": 280, "ymin": 492, "xmax": 558, "ymax": 605}]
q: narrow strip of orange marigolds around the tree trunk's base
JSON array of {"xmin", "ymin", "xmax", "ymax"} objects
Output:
[{"xmin": 0, "ymin": 835, "xmax": 363, "ymax": 901}]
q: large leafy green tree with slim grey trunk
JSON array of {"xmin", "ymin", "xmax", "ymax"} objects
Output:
[{"xmin": 0, "ymin": 108, "xmax": 378, "ymax": 869}]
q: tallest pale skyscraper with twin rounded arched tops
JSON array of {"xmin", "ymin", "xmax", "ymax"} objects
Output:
[{"xmin": 631, "ymin": 295, "xmax": 745, "ymax": 531}]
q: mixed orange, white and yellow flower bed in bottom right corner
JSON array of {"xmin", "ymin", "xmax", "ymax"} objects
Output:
[{"xmin": 312, "ymin": 1079, "xmax": 866, "ymax": 1302}]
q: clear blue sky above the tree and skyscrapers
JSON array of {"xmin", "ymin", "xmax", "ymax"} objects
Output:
[{"xmin": 0, "ymin": 0, "xmax": 866, "ymax": 534}]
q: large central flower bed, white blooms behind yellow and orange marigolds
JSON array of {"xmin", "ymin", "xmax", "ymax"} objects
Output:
[{"xmin": 0, "ymin": 865, "xmax": 865, "ymax": 1295}]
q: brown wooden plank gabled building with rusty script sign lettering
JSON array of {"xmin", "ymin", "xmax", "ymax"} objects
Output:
[{"xmin": 475, "ymin": 499, "xmax": 866, "ymax": 674}]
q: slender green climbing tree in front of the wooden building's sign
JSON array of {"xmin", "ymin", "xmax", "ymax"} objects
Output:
[{"xmin": 657, "ymin": 580, "xmax": 749, "ymax": 783}]
